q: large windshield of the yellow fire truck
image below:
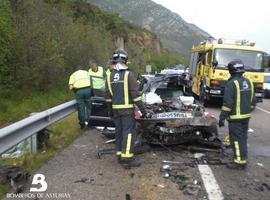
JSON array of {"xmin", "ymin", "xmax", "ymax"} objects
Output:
[{"xmin": 215, "ymin": 49, "xmax": 263, "ymax": 71}]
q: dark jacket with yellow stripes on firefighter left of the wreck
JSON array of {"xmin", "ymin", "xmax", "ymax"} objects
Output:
[{"xmin": 105, "ymin": 69, "xmax": 144, "ymax": 112}]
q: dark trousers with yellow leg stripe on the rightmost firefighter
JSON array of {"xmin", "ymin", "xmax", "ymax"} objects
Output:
[{"xmin": 229, "ymin": 119, "xmax": 249, "ymax": 164}]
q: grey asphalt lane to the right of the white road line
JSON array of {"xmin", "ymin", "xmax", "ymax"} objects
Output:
[{"xmin": 207, "ymin": 99, "xmax": 270, "ymax": 200}]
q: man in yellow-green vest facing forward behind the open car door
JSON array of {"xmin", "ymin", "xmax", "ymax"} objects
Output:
[{"xmin": 89, "ymin": 61, "xmax": 106, "ymax": 96}]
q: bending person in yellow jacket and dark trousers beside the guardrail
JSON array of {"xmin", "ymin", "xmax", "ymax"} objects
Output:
[{"xmin": 69, "ymin": 70, "xmax": 91, "ymax": 129}]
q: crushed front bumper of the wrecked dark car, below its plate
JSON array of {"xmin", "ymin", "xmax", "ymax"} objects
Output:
[{"xmin": 137, "ymin": 115, "xmax": 217, "ymax": 144}]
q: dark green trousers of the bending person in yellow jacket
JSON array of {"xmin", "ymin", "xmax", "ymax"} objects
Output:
[{"xmin": 75, "ymin": 87, "xmax": 91, "ymax": 125}]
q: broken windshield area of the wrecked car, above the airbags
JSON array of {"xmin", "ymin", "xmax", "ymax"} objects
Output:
[{"xmin": 150, "ymin": 81, "xmax": 183, "ymax": 99}]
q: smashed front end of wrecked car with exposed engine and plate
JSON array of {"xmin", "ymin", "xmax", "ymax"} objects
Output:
[{"xmin": 137, "ymin": 100, "xmax": 217, "ymax": 145}]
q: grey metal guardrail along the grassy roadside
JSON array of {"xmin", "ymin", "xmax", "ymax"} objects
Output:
[{"xmin": 0, "ymin": 100, "xmax": 76, "ymax": 154}]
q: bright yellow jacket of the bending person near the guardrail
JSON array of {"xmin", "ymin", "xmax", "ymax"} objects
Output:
[{"xmin": 69, "ymin": 70, "xmax": 90, "ymax": 89}]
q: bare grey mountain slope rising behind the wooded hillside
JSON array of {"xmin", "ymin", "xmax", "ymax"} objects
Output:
[{"xmin": 86, "ymin": 0, "xmax": 210, "ymax": 57}]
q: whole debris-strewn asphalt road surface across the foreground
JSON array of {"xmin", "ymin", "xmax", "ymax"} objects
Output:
[{"xmin": 4, "ymin": 99, "xmax": 270, "ymax": 200}]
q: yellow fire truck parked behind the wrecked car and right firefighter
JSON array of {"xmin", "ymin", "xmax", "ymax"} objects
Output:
[{"xmin": 189, "ymin": 39, "xmax": 264, "ymax": 105}]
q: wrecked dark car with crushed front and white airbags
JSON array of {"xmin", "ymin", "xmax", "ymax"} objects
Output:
[{"xmin": 89, "ymin": 74, "xmax": 218, "ymax": 145}]
